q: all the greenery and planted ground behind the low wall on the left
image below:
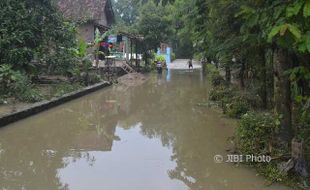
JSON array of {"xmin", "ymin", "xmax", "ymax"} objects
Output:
[{"xmin": 0, "ymin": 0, "xmax": 106, "ymax": 111}]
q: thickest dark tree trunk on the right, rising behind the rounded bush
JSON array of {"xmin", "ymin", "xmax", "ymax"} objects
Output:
[{"xmin": 274, "ymin": 48, "xmax": 293, "ymax": 143}]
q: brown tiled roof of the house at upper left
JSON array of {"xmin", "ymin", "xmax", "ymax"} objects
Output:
[{"xmin": 58, "ymin": 0, "xmax": 113, "ymax": 21}]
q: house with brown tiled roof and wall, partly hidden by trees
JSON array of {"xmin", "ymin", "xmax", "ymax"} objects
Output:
[{"xmin": 57, "ymin": 0, "xmax": 114, "ymax": 42}]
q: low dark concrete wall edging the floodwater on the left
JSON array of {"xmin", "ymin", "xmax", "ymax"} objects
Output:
[{"xmin": 0, "ymin": 82, "xmax": 112, "ymax": 127}]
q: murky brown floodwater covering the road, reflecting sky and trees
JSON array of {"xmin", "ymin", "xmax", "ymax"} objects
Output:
[{"xmin": 0, "ymin": 70, "xmax": 287, "ymax": 190}]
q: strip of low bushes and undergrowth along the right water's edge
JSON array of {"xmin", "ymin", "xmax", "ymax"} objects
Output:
[{"xmin": 206, "ymin": 64, "xmax": 309, "ymax": 189}]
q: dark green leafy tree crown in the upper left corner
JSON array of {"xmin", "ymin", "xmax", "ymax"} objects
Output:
[{"xmin": 0, "ymin": 0, "xmax": 75, "ymax": 76}]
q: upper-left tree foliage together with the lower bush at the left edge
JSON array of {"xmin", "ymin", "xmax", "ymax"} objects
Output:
[{"xmin": 0, "ymin": 0, "xmax": 81, "ymax": 102}]
